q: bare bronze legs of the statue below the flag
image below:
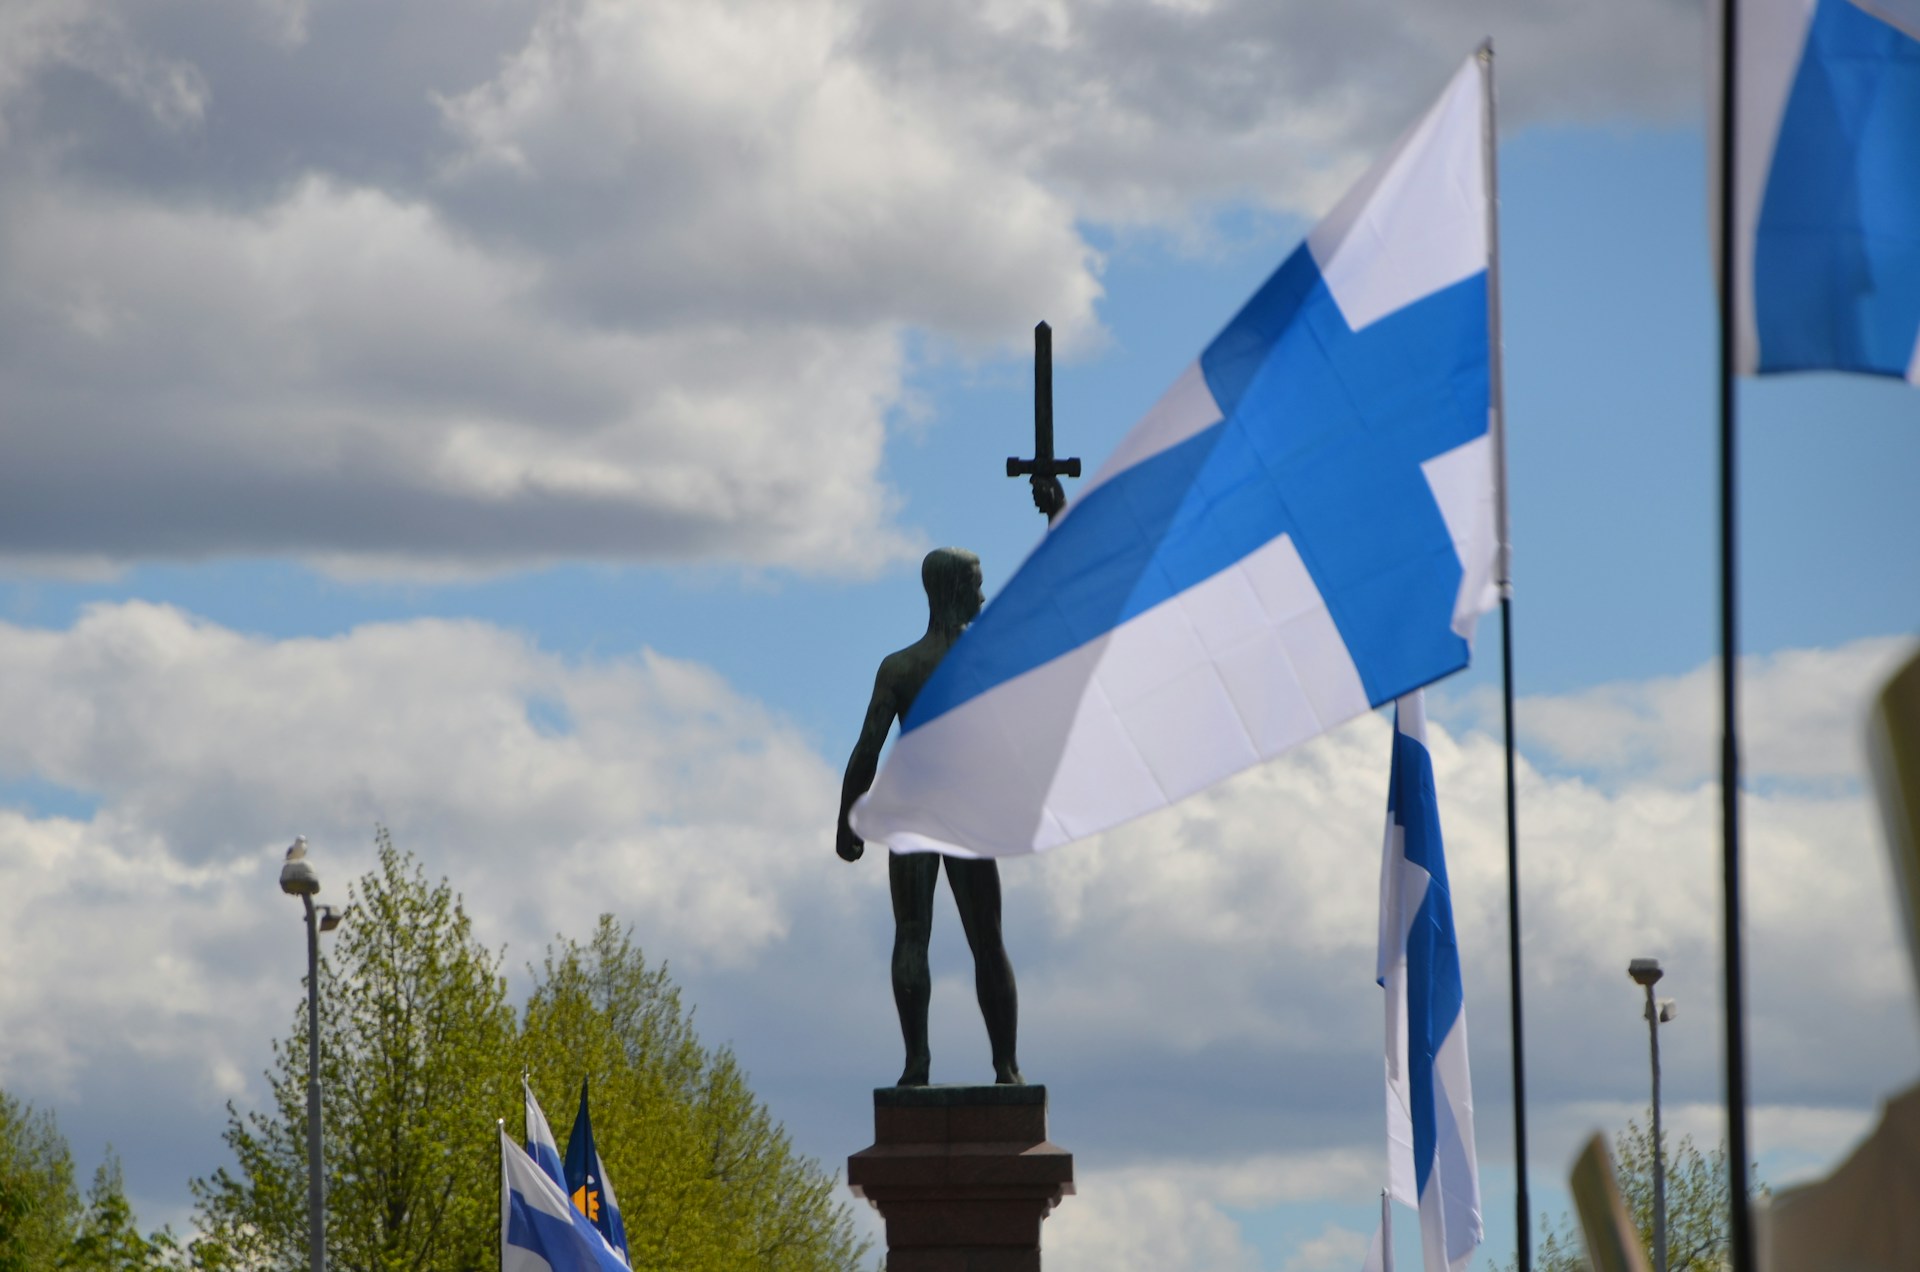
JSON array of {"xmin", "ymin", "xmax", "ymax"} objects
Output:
[{"xmin": 887, "ymin": 853, "xmax": 1023, "ymax": 1086}]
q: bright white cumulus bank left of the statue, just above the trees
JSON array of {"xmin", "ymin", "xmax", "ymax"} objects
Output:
[{"xmin": 0, "ymin": 603, "xmax": 860, "ymax": 961}]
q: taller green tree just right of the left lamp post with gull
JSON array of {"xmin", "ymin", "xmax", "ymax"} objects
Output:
[{"xmin": 194, "ymin": 830, "xmax": 516, "ymax": 1272}]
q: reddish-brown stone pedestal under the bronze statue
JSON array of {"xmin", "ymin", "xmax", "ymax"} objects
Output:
[{"xmin": 847, "ymin": 1086, "xmax": 1073, "ymax": 1272}]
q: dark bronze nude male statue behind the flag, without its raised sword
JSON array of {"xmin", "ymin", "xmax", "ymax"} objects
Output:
[{"xmin": 835, "ymin": 548, "xmax": 1023, "ymax": 1086}]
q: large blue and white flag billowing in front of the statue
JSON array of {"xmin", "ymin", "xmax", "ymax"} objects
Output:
[{"xmin": 852, "ymin": 58, "xmax": 1500, "ymax": 857}]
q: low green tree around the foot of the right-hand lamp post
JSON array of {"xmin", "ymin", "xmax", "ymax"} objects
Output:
[{"xmin": 1509, "ymin": 1118, "xmax": 1766, "ymax": 1272}]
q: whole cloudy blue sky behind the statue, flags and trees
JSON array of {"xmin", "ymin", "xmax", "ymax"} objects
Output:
[{"xmin": 0, "ymin": 0, "xmax": 1920, "ymax": 1272}]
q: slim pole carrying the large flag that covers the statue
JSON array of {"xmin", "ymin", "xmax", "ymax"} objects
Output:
[{"xmin": 1478, "ymin": 37, "xmax": 1532, "ymax": 1272}]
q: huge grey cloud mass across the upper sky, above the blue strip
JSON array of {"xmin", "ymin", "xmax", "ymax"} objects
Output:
[{"xmin": 0, "ymin": 0, "xmax": 1697, "ymax": 573}]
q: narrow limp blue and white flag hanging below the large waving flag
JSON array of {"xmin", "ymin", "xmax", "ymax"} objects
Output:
[{"xmin": 1379, "ymin": 692, "xmax": 1482, "ymax": 1272}]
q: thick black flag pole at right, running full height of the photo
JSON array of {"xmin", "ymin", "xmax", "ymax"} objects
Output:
[{"xmin": 1720, "ymin": 0, "xmax": 1755, "ymax": 1272}]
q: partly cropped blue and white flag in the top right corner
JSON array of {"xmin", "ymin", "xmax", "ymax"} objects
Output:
[{"xmin": 1722, "ymin": 0, "xmax": 1920, "ymax": 384}]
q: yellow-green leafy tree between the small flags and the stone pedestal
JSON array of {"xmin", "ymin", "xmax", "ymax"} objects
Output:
[{"xmin": 522, "ymin": 915, "xmax": 864, "ymax": 1272}]
